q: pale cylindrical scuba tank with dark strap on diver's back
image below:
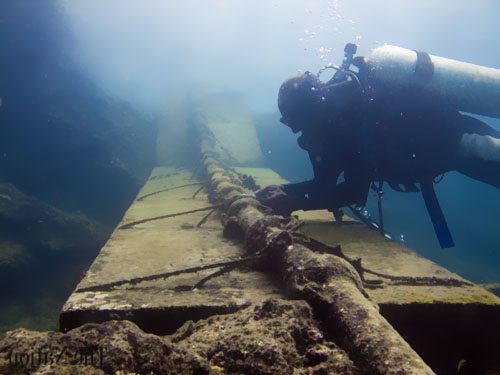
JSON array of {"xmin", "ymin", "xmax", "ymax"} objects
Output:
[{"xmin": 362, "ymin": 45, "xmax": 500, "ymax": 118}]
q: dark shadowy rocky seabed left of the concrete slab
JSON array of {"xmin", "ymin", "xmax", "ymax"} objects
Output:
[{"xmin": 0, "ymin": 183, "xmax": 107, "ymax": 335}]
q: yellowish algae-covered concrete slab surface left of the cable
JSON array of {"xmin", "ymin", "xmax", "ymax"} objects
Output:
[{"xmin": 60, "ymin": 167, "xmax": 286, "ymax": 333}]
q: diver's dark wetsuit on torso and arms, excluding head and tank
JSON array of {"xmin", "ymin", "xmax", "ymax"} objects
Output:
[{"xmin": 283, "ymin": 81, "xmax": 500, "ymax": 210}]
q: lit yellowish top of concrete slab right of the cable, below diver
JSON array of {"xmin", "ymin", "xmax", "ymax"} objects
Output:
[{"xmin": 236, "ymin": 168, "xmax": 500, "ymax": 313}]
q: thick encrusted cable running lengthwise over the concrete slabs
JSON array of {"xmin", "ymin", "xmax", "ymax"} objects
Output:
[{"xmin": 194, "ymin": 116, "xmax": 434, "ymax": 375}]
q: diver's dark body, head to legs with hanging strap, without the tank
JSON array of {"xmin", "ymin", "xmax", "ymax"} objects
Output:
[{"xmin": 256, "ymin": 52, "xmax": 500, "ymax": 247}]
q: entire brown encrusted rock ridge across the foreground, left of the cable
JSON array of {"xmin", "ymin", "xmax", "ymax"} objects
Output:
[{"xmin": 0, "ymin": 300, "xmax": 359, "ymax": 374}]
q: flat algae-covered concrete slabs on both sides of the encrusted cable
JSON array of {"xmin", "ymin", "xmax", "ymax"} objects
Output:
[{"xmin": 64, "ymin": 167, "xmax": 500, "ymax": 332}]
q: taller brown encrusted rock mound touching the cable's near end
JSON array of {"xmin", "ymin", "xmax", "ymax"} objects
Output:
[{"xmin": 172, "ymin": 300, "xmax": 357, "ymax": 374}]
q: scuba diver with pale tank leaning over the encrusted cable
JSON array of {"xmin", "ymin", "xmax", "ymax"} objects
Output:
[{"xmin": 256, "ymin": 44, "xmax": 500, "ymax": 247}]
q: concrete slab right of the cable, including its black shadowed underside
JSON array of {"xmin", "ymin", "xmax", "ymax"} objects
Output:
[{"xmin": 239, "ymin": 168, "xmax": 500, "ymax": 374}]
